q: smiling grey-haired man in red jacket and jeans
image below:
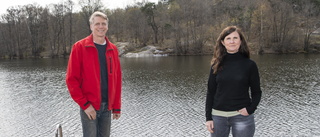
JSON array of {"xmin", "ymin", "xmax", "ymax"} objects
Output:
[{"xmin": 66, "ymin": 12, "xmax": 122, "ymax": 137}]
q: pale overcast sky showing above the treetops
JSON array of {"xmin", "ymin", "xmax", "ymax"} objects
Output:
[{"xmin": 0, "ymin": 0, "xmax": 158, "ymax": 15}]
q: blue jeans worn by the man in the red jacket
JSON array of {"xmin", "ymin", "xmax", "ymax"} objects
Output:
[{"xmin": 80, "ymin": 103, "xmax": 111, "ymax": 137}]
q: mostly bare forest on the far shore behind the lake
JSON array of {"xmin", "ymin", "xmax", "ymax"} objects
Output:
[{"xmin": 0, "ymin": 0, "xmax": 320, "ymax": 59}]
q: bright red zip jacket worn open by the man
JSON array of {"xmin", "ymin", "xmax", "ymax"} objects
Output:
[{"xmin": 66, "ymin": 34, "xmax": 122, "ymax": 113}]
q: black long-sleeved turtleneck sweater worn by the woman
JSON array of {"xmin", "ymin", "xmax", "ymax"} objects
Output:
[{"xmin": 205, "ymin": 53, "xmax": 261, "ymax": 121}]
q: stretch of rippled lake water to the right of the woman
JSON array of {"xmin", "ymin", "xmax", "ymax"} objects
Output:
[{"xmin": 257, "ymin": 55, "xmax": 320, "ymax": 136}]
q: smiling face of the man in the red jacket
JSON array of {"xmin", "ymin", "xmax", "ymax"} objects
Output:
[{"xmin": 90, "ymin": 17, "xmax": 108, "ymax": 37}]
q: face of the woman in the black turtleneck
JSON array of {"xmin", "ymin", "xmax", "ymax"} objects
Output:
[{"xmin": 221, "ymin": 31, "xmax": 241, "ymax": 54}]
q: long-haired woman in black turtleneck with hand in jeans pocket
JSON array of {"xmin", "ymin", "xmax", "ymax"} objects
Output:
[{"xmin": 206, "ymin": 26, "xmax": 261, "ymax": 137}]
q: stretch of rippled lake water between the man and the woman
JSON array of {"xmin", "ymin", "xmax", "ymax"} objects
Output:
[{"xmin": 119, "ymin": 57, "xmax": 209, "ymax": 136}]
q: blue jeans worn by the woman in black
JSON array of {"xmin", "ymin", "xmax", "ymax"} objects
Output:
[{"xmin": 211, "ymin": 115, "xmax": 255, "ymax": 137}]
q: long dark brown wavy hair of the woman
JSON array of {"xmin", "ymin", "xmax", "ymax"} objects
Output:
[{"xmin": 211, "ymin": 26, "xmax": 250, "ymax": 74}]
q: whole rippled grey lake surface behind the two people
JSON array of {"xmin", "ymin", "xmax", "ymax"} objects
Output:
[{"xmin": 0, "ymin": 55, "xmax": 320, "ymax": 137}]
